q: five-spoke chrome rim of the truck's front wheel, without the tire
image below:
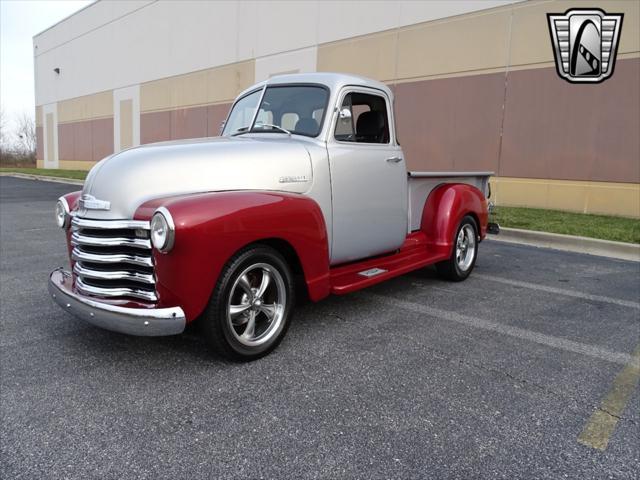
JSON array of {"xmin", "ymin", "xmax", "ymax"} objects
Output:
[{"xmin": 227, "ymin": 263, "xmax": 287, "ymax": 347}]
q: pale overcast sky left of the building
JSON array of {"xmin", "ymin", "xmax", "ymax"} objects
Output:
[{"xmin": 0, "ymin": 0, "xmax": 93, "ymax": 133}]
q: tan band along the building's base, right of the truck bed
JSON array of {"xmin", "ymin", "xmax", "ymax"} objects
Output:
[{"xmin": 491, "ymin": 177, "xmax": 640, "ymax": 218}]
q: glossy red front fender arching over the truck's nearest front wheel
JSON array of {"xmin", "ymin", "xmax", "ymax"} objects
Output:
[{"xmin": 134, "ymin": 191, "xmax": 330, "ymax": 321}]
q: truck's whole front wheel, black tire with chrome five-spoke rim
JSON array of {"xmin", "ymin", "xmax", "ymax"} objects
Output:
[{"xmin": 200, "ymin": 245, "xmax": 295, "ymax": 362}]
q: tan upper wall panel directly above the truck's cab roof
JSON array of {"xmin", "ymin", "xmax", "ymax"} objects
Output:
[{"xmin": 317, "ymin": 32, "xmax": 397, "ymax": 80}]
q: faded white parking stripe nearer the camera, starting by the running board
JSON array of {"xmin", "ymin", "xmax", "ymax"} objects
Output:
[{"xmin": 362, "ymin": 293, "xmax": 640, "ymax": 368}]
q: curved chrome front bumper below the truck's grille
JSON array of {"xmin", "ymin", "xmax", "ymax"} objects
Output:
[{"xmin": 49, "ymin": 268, "xmax": 186, "ymax": 336}]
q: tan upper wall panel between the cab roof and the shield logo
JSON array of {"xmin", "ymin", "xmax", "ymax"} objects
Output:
[{"xmin": 397, "ymin": 9, "xmax": 511, "ymax": 79}]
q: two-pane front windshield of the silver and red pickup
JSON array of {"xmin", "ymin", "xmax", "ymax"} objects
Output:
[{"xmin": 222, "ymin": 85, "xmax": 329, "ymax": 137}]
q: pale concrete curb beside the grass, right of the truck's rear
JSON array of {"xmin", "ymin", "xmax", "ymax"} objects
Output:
[{"xmin": 487, "ymin": 227, "xmax": 640, "ymax": 262}]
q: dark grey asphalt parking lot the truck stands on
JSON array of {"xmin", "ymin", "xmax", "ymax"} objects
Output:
[{"xmin": 0, "ymin": 177, "xmax": 640, "ymax": 479}]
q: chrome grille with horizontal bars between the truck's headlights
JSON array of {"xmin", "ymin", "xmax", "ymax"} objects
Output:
[{"xmin": 71, "ymin": 217, "xmax": 158, "ymax": 302}]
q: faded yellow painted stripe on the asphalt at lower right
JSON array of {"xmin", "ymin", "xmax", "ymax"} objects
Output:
[{"xmin": 578, "ymin": 345, "xmax": 640, "ymax": 451}]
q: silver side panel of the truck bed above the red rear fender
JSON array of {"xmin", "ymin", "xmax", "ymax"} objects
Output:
[{"xmin": 407, "ymin": 172, "xmax": 493, "ymax": 233}]
